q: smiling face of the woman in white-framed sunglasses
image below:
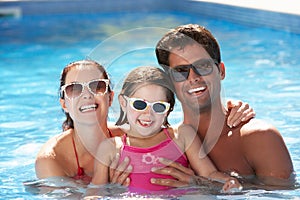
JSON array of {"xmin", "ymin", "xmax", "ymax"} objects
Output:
[{"xmin": 60, "ymin": 66, "xmax": 113, "ymax": 126}]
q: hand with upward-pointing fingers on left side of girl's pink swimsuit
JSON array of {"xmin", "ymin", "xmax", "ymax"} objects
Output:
[{"xmin": 109, "ymin": 154, "xmax": 132, "ymax": 186}]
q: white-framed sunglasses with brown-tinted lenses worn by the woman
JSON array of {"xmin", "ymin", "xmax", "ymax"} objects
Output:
[{"xmin": 60, "ymin": 79, "xmax": 109, "ymax": 99}]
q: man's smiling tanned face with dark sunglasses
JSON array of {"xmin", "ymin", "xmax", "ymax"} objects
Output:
[{"xmin": 169, "ymin": 44, "xmax": 225, "ymax": 112}]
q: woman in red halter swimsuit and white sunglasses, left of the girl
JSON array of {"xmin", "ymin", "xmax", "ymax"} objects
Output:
[{"xmin": 35, "ymin": 60, "xmax": 127, "ymax": 185}]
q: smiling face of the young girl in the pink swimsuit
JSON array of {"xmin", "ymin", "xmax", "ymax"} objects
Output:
[{"xmin": 120, "ymin": 84, "xmax": 167, "ymax": 137}]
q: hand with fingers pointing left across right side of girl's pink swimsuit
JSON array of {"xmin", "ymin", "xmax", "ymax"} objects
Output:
[{"xmin": 151, "ymin": 158, "xmax": 195, "ymax": 187}]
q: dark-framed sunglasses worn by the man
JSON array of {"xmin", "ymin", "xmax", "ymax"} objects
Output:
[{"xmin": 169, "ymin": 59, "xmax": 219, "ymax": 82}]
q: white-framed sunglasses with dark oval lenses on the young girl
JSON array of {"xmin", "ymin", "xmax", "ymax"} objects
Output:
[{"xmin": 123, "ymin": 95, "xmax": 170, "ymax": 114}]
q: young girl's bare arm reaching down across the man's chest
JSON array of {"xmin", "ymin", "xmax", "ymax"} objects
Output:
[{"xmin": 178, "ymin": 125, "xmax": 242, "ymax": 192}]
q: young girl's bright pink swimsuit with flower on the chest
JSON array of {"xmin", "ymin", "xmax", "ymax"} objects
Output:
[{"xmin": 120, "ymin": 128, "xmax": 188, "ymax": 190}]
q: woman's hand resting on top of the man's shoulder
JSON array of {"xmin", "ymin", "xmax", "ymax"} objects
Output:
[{"xmin": 227, "ymin": 100, "xmax": 255, "ymax": 128}]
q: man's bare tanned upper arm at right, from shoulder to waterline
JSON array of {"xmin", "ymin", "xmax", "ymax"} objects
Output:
[{"xmin": 241, "ymin": 119, "xmax": 295, "ymax": 186}]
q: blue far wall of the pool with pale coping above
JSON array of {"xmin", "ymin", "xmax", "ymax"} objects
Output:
[{"xmin": 0, "ymin": 0, "xmax": 300, "ymax": 34}]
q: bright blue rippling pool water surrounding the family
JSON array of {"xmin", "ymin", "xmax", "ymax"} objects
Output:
[{"xmin": 0, "ymin": 12, "xmax": 300, "ymax": 199}]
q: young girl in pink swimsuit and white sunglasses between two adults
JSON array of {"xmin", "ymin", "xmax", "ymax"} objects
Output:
[{"xmin": 92, "ymin": 67, "xmax": 241, "ymax": 191}]
